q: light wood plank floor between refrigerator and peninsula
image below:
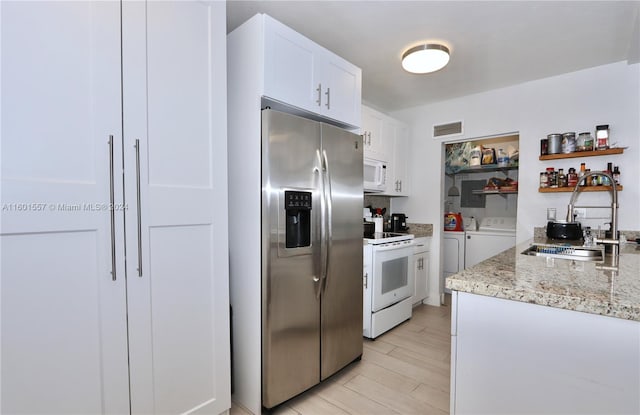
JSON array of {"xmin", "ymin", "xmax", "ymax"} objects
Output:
[{"xmin": 231, "ymin": 296, "xmax": 451, "ymax": 415}]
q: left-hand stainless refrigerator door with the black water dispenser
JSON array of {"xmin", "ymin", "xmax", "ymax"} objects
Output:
[{"xmin": 260, "ymin": 110, "xmax": 321, "ymax": 408}]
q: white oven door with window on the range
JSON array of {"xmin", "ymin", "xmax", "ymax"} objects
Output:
[{"xmin": 372, "ymin": 244, "xmax": 414, "ymax": 312}]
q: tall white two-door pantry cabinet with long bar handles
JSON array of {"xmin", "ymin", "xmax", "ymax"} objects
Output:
[{"xmin": 0, "ymin": 1, "xmax": 230, "ymax": 414}]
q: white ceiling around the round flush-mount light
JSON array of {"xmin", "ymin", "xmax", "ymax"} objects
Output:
[{"xmin": 227, "ymin": 0, "xmax": 640, "ymax": 112}]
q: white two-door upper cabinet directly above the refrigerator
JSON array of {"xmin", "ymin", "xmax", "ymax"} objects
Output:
[{"xmin": 260, "ymin": 15, "xmax": 362, "ymax": 127}]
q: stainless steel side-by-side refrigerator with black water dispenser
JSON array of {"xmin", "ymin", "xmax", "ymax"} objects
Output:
[{"xmin": 262, "ymin": 109, "xmax": 363, "ymax": 408}]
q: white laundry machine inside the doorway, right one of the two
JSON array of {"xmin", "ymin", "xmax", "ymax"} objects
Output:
[{"xmin": 464, "ymin": 217, "xmax": 516, "ymax": 268}]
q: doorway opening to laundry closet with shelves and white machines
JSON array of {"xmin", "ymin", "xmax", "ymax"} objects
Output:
[{"xmin": 440, "ymin": 133, "xmax": 520, "ymax": 297}]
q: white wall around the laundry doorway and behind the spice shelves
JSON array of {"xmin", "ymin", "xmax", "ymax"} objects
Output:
[{"xmin": 391, "ymin": 62, "xmax": 640, "ymax": 303}]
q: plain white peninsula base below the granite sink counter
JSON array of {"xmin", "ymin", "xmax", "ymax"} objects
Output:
[{"xmin": 450, "ymin": 291, "xmax": 640, "ymax": 414}]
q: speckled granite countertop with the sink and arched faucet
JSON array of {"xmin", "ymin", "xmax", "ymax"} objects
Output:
[{"xmin": 446, "ymin": 239, "xmax": 640, "ymax": 321}]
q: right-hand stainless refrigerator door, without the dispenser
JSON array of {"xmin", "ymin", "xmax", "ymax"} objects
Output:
[{"xmin": 320, "ymin": 124, "xmax": 363, "ymax": 380}]
